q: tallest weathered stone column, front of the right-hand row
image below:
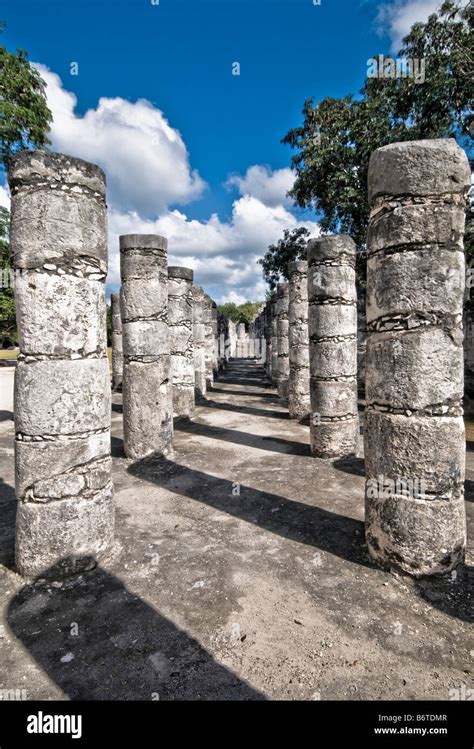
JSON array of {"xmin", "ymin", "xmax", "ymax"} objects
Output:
[{"xmin": 365, "ymin": 140, "xmax": 470, "ymax": 576}]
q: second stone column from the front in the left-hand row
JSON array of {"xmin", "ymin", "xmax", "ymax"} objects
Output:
[{"xmin": 120, "ymin": 234, "xmax": 173, "ymax": 460}]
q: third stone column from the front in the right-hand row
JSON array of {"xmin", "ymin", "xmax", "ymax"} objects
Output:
[{"xmin": 288, "ymin": 260, "xmax": 311, "ymax": 419}]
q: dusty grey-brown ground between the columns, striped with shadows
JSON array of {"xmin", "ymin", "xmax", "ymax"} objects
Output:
[{"xmin": 0, "ymin": 361, "xmax": 474, "ymax": 701}]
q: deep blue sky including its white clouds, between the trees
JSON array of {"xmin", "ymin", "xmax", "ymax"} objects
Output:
[{"xmin": 0, "ymin": 0, "xmax": 436, "ymax": 301}]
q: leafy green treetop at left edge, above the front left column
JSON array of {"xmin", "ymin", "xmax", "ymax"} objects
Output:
[{"xmin": 0, "ymin": 46, "xmax": 53, "ymax": 168}]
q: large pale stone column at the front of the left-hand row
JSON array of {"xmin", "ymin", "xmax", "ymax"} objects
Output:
[{"xmin": 9, "ymin": 151, "xmax": 114, "ymax": 576}]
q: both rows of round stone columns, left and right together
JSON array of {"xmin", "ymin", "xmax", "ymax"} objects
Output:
[{"xmin": 9, "ymin": 140, "xmax": 470, "ymax": 575}]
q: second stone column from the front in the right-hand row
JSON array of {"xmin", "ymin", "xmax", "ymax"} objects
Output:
[{"xmin": 308, "ymin": 234, "xmax": 359, "ymax": 458}]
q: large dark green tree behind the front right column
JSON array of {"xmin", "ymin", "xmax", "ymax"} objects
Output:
[{"xmin": 284, "ymin": 0, "xmax": 474, "ymax": 271}]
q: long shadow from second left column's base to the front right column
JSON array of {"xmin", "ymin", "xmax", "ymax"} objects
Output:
[{"xmin": 127, "ymin": 456, "xmax": 373, "ymax": 567}]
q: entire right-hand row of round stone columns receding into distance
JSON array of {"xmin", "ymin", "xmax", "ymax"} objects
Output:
[{"xmin": 248, "ymin": 140, "xmax": 470, "ymax": 576}]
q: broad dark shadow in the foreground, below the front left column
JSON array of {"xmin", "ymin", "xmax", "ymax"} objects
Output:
[{"xmin": 8, "ymin": 567, "xmax": 265, "ymax": 700}]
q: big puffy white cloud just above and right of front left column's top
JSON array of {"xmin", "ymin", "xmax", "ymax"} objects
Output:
[{"xmin": 36, "ymin": 64, "xmax": 206, "ymax": 216}]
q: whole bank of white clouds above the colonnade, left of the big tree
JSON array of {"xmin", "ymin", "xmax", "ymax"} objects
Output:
[{"xmin": 5, "ymin": 64, "xmax": 319, "ymax": 303}]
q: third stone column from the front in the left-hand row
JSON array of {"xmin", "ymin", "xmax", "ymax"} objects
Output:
[{"xmin": 168, "ymin": 266, "xmax": 194, "ymax": 418}]
